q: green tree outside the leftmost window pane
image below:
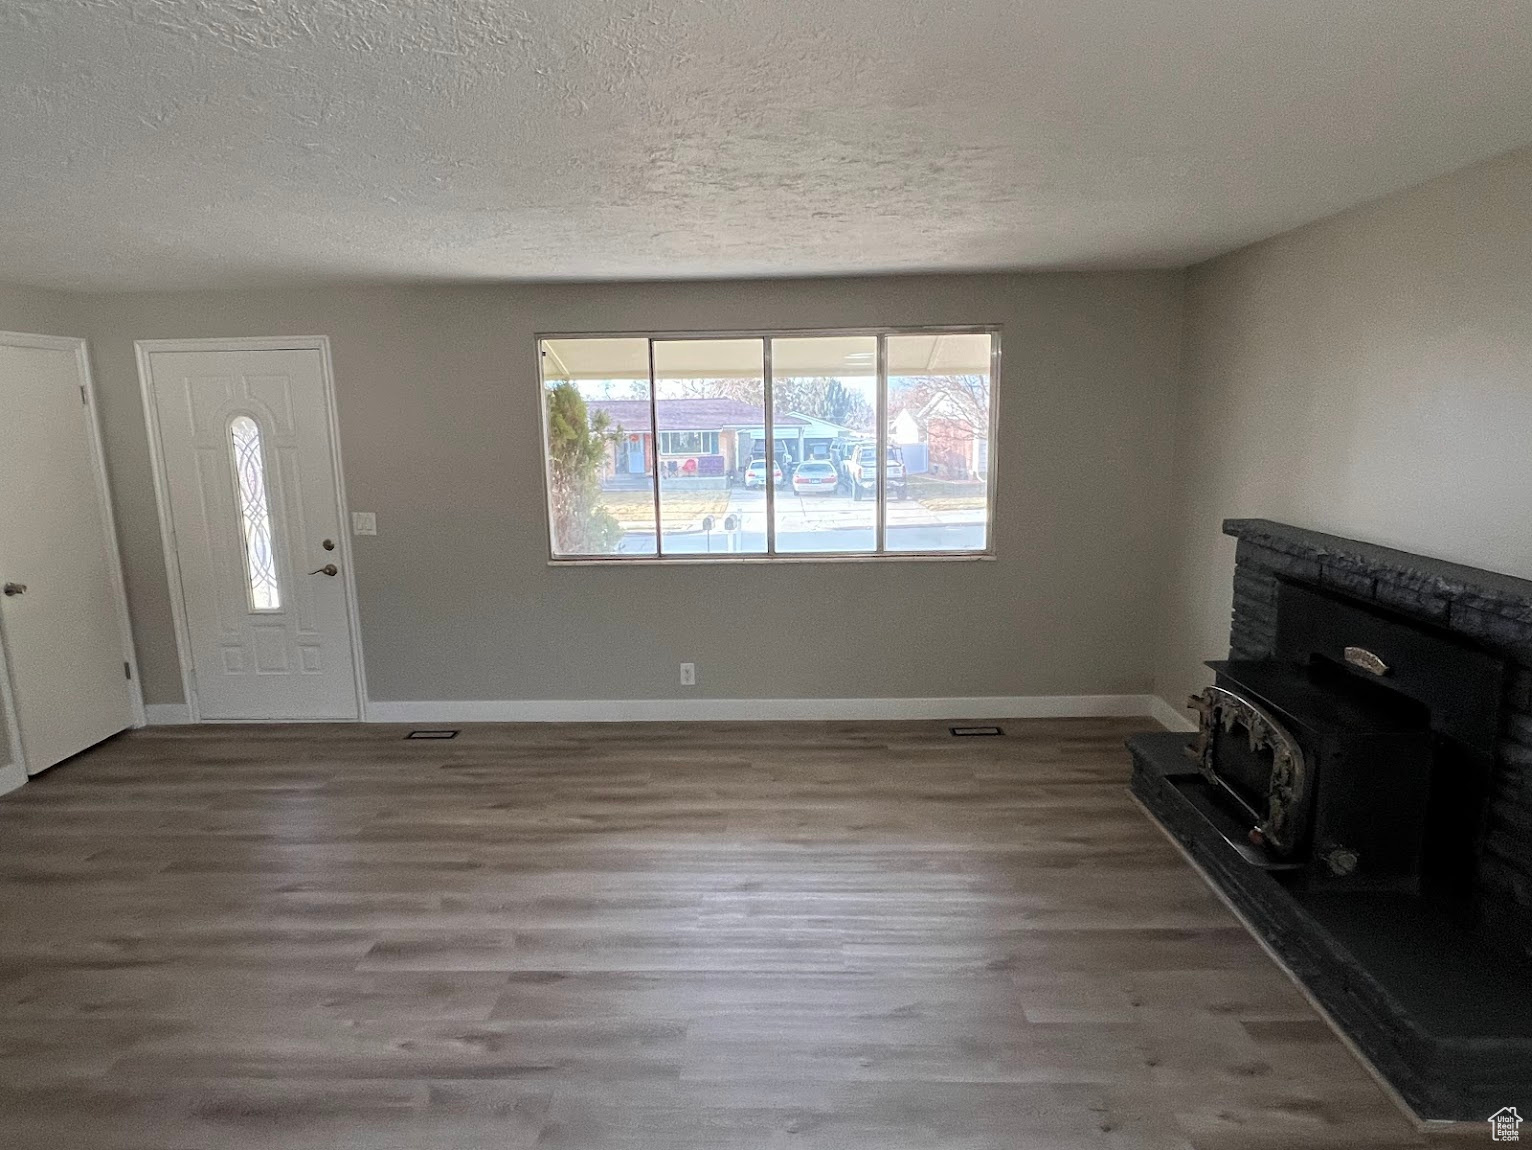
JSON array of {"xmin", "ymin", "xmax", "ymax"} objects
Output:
[{"xmin": 548, "ymin": 381, "xmax": 622, "ymax": 554}]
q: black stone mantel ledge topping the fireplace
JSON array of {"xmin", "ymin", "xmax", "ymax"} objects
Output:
[{"xmin": 1224, "ymin": 519, "xmax": 1532, "ymax": 625}]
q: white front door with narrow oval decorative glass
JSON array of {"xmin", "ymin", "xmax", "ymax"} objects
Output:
[{"xmin": 144, "ymin": 346, "xmax": 360, "ymax": 718}]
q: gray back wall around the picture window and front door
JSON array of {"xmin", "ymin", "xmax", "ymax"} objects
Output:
[{"xmin": 75, "ymin": 273, "xmax": 1181, "ymax": 703}]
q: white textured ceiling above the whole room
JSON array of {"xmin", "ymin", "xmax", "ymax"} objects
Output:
[{"xmin": 0, "ymin": 0, "xmax": 1532, "ymax": 289}]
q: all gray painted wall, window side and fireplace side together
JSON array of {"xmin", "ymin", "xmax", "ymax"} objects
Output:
[{"xmin": 14, "ymin": 132, "xmax": 1532, "ymax": 728}]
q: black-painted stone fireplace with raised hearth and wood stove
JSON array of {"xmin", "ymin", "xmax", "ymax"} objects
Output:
[{"xmin": 1129, "ymin": 519, "xmax": 1532, "ymax": 1121}]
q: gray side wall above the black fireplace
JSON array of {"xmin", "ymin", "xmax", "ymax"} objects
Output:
[{"xmin": 1155, "ymin": 149, "xmax": 1532, "ymax": 704}]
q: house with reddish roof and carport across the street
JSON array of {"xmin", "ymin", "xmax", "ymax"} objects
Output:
[{"xmin": 587, "ymin": 398, "xmax": 858, "ymax": 481}]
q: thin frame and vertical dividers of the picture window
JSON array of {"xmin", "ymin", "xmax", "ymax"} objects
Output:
[{"xmin": 532, "ymin": 323, "xmax": 1000, "ymax": 567}]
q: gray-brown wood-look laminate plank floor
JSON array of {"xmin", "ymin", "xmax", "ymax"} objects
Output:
[{"xmin": 0, "ymin": 720, "xmax": 1452, "ymax": 1150}]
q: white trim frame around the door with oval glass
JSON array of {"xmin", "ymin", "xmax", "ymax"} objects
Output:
[{"xmin": 133, "ymin": 335, "xmax": 368, "ymax": 723}]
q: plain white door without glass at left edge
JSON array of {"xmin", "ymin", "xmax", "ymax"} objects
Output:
[{"xmin": 0, "ymin": 334, "xmax": 139, "ymax": 775}]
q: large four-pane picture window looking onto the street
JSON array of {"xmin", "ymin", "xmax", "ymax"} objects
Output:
[{"xmin": 538, "ymin": 328, "xmax": 1000, "ymax": 562}]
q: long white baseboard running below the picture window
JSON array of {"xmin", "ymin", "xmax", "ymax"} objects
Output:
[{"xmin": 366, "ymin": 695, "xmax": 1158, "ymax": 723}]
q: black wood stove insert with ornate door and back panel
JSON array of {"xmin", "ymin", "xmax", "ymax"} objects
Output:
[{"xmin": 1187, "ymin": 583, "xmax": 1504, "ymax": 907}]
